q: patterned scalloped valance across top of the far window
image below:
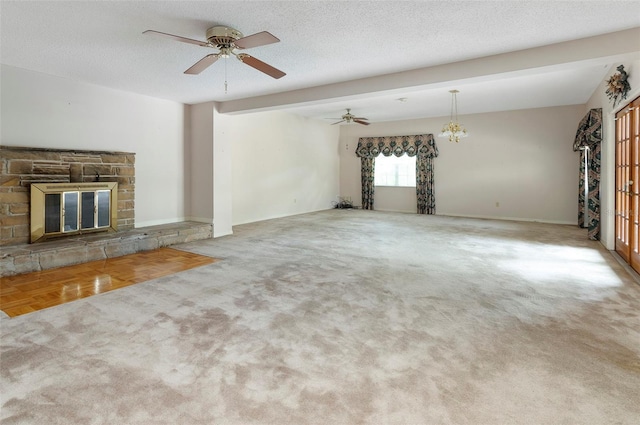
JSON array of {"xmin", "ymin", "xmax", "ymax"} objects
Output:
[{"xmin": 356, "ymin": 134, "xmax": 438, "ymax": 158}]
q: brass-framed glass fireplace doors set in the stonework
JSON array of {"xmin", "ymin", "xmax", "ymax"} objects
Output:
[{"xmin": 31, "ymin": 182, "xmax": 118, "ymax": 243}]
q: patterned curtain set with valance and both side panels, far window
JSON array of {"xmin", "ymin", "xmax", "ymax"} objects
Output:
[{"xmin": 356, "ymin": 134, "xmax": 438, "ymax": 214}]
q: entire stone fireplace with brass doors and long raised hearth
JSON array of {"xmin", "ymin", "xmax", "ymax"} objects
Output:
[{"xmin": 0, "ymin": 146, "xmax": 213, "ymax": 277}]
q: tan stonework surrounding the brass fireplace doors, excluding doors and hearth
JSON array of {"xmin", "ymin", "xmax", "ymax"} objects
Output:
[{"xmin": 0, "ymin": 146, "xmax": 135, "ymax": 245}]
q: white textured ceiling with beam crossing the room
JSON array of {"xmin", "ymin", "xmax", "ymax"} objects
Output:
[{"xmin": 0, "ymin": 0, "xmax": 640, "ymax": 122}]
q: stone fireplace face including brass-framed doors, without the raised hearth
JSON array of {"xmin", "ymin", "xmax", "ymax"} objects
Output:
[{"xmin": 0, "ymin": 146, "xmax": 135, "ymax": 245}]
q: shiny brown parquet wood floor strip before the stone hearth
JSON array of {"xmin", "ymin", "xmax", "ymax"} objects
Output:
[{"xmin": 0, "ymin": 248, "xmax": 218, "ymax": 317}]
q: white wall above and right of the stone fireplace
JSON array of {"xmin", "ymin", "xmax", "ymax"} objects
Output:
[{"xmin": 0, "ymin": 65, "xmax": 186, "ymax": 227}]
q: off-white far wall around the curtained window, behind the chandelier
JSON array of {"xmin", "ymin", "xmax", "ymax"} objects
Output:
[{"xmin": 340, "ymin": 105, "xmax": 584, "ymax": 224}]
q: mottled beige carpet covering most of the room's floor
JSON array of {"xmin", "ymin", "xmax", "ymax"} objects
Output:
[{"xmin": 0, "ymin": 210, "xmax": 640, "ymax": 425}]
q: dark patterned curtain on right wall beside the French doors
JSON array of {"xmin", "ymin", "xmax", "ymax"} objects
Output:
[{"xmin": 573, "ymin": 108, "xmax": 602, "ymax": 240}]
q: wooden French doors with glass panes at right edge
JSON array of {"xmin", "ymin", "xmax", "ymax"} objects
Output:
[{"xmin": 615, "ymin": 97, "xmax": 640, "ymax": 273}]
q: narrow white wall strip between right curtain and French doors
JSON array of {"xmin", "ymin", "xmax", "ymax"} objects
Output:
[{"xmin": 583, "ymin": 60, "xmax": 640, "ymax": 250}]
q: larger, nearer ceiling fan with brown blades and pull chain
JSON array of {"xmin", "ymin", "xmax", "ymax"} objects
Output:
[{"xmin": 143, "ymin": 25, "xmax": 286, "ymax": 78}]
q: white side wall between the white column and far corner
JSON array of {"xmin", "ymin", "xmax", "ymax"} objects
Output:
[{"xmin": 225, "ymin": 112, "xmax": 340, "ymax": 225}]
